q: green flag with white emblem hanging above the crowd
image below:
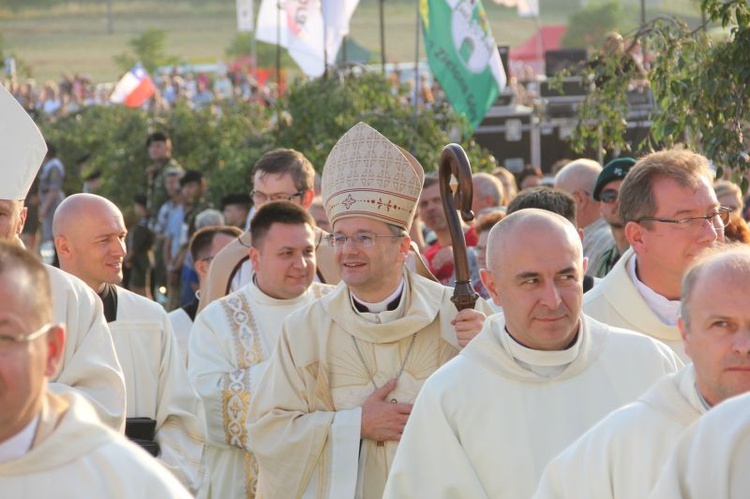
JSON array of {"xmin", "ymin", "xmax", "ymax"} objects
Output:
[{"xmin": 419, "ymin": 0, "xmax": 506, "ymax": 130}]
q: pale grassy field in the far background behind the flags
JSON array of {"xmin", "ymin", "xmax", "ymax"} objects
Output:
[{"xmin": 0, "ymin": 0, "xmax": 697, "ymax": 82}]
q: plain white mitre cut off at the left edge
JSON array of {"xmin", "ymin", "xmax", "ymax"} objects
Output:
[{"xmin": 0, "ymin": 85, "xmax": 47, "ymax": 201}]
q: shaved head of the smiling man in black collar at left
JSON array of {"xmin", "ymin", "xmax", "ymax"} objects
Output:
[{"xmin": 52, "ymin": 194, "xmax": 127, "ymax": 292}]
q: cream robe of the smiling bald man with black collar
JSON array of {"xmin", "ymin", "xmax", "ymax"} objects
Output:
[{"xmin": 109, "ymin": 287, "xmax": 206, "ymax": 492}]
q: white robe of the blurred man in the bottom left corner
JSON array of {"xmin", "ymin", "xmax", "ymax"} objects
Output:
[{"xmin": 0, "ymin": 390, "xmax": 192, "ymax": 499}]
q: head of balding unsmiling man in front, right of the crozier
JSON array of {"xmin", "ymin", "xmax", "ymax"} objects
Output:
[{"xmin": 480, "ymin": 208, "xmax": 585, "ymax": 350}]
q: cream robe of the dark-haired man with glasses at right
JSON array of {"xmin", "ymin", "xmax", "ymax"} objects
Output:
[{"xmin": 583, "ymin": 248, "xmax": 690, "ymax": 363}]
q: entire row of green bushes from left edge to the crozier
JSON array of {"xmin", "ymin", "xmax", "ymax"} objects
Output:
[{"xmin": 36, "ymin": 70, "xmax": 495, "ymax": 209}]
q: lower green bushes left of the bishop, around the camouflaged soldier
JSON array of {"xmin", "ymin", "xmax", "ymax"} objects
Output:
[{"xmin": 42, "ymin": 104, "xmax": 271, "ymax": 207}]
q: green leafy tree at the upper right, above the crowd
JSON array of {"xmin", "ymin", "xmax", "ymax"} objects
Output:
[{"xmin": 573, "ymin": 0, "xmax": 750, "ymax": 183}]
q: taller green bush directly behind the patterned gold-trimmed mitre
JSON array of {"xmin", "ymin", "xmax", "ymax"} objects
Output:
[{"xmin": 279, "ymin": 73, "xmax": 494, "ymax": 171}]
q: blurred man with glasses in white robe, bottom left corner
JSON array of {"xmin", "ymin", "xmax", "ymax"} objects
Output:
[{"xmin": 0, "ymin": 241, "xmax": 192, "ymax": 499}]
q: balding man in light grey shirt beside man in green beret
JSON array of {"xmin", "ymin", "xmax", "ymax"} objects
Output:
[{"xmin": 555, "ymin": 159, "xmax": 614, "ymax": 277}]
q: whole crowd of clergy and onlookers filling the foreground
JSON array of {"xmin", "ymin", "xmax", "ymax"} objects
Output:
[{"xmin": 0, "ymin": 74, "xmax": 750, "ymax": 499}]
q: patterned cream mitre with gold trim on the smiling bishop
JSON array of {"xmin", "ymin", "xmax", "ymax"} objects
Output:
[{"xmin": 322, "ymin": 122, "xmax": 424, "ymax": 231}]
